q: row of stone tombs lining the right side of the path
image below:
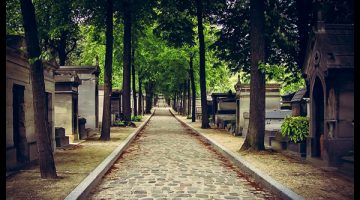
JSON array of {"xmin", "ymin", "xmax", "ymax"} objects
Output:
[{"xmin": 173, "ymin": 24, "xmax": 354, "ymax": 173}]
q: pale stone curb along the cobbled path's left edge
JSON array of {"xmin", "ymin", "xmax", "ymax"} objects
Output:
[{"xmin": 65, "ymin": 111, "xmax": 155, "ymax": 200}]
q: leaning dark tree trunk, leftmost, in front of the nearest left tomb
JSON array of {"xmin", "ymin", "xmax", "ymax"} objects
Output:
[{"xmin": 20, "ymin": 0, "xmax": 57, "ymax": 179}]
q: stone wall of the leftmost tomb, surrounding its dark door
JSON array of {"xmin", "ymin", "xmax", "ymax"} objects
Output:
[{"xmin": 6, "ymin": 47, "xmax": 56, "ymax": 169}]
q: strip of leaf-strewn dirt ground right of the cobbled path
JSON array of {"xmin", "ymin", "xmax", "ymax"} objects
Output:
[{"xmin": 178, "ymin": 115, "xmax": 354, "ymax": 200}]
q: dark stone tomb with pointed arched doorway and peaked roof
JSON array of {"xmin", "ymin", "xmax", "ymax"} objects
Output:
[{"xmin": 303, "ymin": 22, "xmax": 354, "ymax": 166}]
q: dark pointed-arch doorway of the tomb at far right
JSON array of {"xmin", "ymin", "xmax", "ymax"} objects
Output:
[{"xmin": 312, "ymin": 78, "xmax": 324, "ymax": 158}]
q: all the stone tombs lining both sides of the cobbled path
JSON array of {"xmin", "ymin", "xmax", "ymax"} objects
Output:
[{"xmin": 6, "ymin": 24, "xmax": 354, "ymax": 173}]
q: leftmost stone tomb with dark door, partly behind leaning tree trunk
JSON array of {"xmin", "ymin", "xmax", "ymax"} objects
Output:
[{"xmin": 6, "ymin": 36, "xmax": 58, "ymax": 170}]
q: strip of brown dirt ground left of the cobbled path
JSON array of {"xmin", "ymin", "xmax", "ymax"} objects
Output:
[{"xmin": 6, "ymin": 115, "xmax": 150, "ymax": 199}]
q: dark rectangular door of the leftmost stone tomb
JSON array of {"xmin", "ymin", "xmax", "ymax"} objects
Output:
[{"xmin": 13, "ymin": 85, "xmax": 29, "ymax": 163}]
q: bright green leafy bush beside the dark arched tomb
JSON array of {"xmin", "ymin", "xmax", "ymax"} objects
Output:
[{"xmin": 281, "ymin": 116, "xmax": 309, "ymax": 143}]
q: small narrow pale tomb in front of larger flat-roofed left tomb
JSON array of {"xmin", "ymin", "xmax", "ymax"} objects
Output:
[{"xmin": 55, "ymin": 71, "xmax": 81, "ymax": 143}]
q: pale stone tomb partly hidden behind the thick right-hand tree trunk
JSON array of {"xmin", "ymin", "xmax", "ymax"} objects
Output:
[{"xmin": 235, "ymin": 77, "xmax": 280, "ymax": 137}]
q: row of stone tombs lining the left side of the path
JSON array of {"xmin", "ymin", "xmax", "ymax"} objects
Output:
[{"xmin": 6, "ymin": 36, "xmax": 145, "ymax": 171}]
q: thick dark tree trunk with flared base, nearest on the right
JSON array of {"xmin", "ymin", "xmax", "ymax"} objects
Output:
[{"xmin": 241, "ymin": 0, "xmax": 265, "ymax": 150}]
